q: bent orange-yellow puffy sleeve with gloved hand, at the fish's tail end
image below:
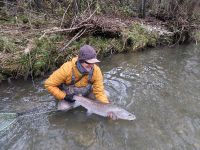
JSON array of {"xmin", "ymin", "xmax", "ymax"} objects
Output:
[{"xmin": 44, "ymin": 63, "xmax": 69, "ymax": 100}]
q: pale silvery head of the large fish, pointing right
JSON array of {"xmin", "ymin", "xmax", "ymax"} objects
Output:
[{"xmin": 115, "ymin": 109, "xmax": 136, "ymax": 120}]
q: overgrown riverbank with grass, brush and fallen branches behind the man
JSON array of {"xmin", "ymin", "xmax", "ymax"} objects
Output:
[{"xmin": 0, "ymin": 2, "xmax": 200, "ymax": 81}]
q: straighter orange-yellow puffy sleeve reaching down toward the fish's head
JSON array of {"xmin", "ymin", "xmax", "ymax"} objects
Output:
[{"xmin": 93, "ymin": 66, "xmax": 109, "ymax": 103}]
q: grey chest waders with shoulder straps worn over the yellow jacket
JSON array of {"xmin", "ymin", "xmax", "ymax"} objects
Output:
[{"xmin": 61, "ymin": 68, "xmax": 94, "ymax": 96}]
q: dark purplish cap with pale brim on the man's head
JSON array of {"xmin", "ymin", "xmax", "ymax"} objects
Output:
[{"xmin": 78, "ymin": 45, "xmax": 100, "ymax": 64}]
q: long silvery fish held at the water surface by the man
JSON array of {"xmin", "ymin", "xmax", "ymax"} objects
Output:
[{"xmin": 73, "ymin": 95, "xmax": 136, "ymax": 120}]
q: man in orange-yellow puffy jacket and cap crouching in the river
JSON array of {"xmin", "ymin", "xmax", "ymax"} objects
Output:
[{"xmin": 45, "ymin": 45, "xmax": 114, "ymax": 119}]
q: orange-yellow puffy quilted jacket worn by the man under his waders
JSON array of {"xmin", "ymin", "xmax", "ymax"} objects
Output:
[{"xmin": 44, "ymin": 57, "xmax": 109, "ymax": 103}]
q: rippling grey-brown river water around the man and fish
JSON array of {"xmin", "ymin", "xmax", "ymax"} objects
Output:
[{"xmin": 0, "ymin": 44, "xmax": 200, "ymax": 150}]
